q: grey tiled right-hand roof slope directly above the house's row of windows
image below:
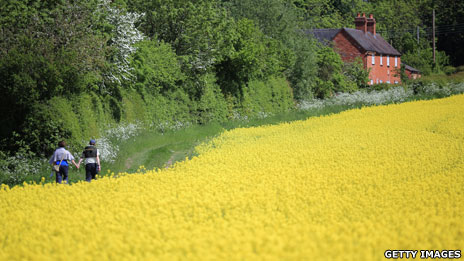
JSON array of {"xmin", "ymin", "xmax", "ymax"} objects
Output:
[{"xmin": 343, "ymin": 28, "xmax": 401, "ymax": 56}]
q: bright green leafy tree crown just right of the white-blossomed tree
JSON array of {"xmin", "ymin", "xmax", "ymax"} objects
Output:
[{"xmin": 129, "ymin": 0, "xmax": 230, "ymax": 74}]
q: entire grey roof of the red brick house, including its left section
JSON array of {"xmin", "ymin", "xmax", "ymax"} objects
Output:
[{"xmin": 306, "ymin": 28, "xmax": 401, "ymax": 56}]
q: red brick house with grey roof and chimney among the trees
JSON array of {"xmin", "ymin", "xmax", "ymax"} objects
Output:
[{"xmin": 309, "ymin": 14, "xmax": 401, "ymax": 85}]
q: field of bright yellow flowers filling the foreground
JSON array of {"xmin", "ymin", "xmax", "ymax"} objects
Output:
[{"xmin": 0, "ymin": 95, "xmax": 464, "ymax": 260}]
